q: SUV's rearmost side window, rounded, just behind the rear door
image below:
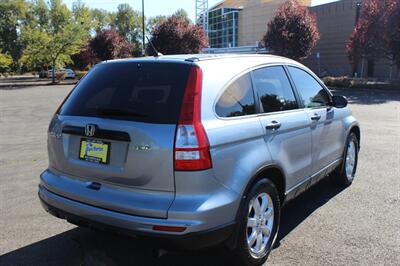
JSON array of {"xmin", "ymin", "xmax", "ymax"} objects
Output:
[{"xmin": 215, "ymin": 74, "xmax": 256, "ymax": 117}]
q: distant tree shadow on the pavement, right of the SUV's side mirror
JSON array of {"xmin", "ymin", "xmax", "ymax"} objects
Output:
[{"xmin": 331, "ymin": 88, "xmax": 400, "ymax": 105}]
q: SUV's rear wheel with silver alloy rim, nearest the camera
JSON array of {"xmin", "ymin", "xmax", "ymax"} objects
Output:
[{"xmin": 233, "ymin": 179, "xmax": 281, "ymax": 266}]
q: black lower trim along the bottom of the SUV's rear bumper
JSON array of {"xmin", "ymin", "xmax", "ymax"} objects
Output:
[{"xmin": 39, "ymin": 188, "xmax": 235, "ymax": 249}]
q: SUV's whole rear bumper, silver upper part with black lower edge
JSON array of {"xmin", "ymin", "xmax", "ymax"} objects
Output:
[{"xmin": 38, "ymin": 170, "xmax": 241, "ymax": 249}]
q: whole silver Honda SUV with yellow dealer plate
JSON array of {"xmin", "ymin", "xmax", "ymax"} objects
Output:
[{"xmin": 39, "ymin": 55, "xmax": 360, "ymax": 265}]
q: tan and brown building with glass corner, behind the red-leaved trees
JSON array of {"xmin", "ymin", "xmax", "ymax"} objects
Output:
[{"xmin": 205, "ymin": 0, "xmax": 397, "ymax": 79}]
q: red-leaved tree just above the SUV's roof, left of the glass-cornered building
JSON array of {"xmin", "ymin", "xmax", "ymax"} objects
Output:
[{"xmin": 147, "ymin": 16, "xmax": 208, "ymax": 54}]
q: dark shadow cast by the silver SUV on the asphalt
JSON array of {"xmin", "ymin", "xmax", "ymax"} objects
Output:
[{"xmin": 0, "ymin": 178, "xmax": 342, "ymax": 266}]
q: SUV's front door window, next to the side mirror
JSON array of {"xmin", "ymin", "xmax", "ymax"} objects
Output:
[{"xmin": 289, "ymin": 67, "xmax": 330, "ymax": 108}]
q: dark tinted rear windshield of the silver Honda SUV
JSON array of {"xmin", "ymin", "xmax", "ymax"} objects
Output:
[{"xmin": 59, "ymin": 62, "xmax": 190, "ymax": 124}]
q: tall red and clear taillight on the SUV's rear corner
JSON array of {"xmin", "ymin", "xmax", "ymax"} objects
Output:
[{"xmin": 174, "ymin": 67, "xmax": 212, "ymax": 171}]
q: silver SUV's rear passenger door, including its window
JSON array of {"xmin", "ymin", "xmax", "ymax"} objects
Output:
[{"xmin": 252, "ymin": 66, "xmax": 312, "ymax": 190}]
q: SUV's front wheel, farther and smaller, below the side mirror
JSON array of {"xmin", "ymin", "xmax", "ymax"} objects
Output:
[{"xmin": 335, "ymin": 132, "xmax": 359, "ymax": 187}]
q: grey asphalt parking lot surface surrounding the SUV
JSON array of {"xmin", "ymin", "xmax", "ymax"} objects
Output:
[{"xmin": 0, "ymin": 86, "xmax": 400, "ymax": 266}]
